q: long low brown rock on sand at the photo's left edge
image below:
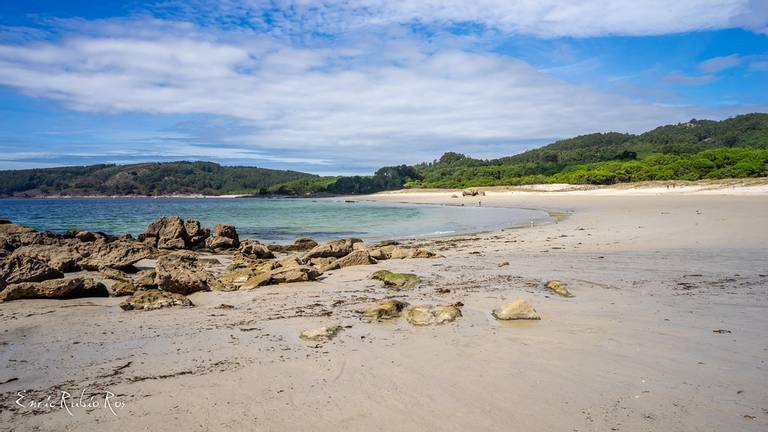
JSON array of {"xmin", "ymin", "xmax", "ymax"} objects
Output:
[{"xmin": 0, "ymin": 278, "xmax": 109, "ymax": 301}]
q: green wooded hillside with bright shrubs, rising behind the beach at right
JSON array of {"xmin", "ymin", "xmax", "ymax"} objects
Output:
[{"xmin": 406, "ymin": 114, "xmax": 768, "ymax": 188}]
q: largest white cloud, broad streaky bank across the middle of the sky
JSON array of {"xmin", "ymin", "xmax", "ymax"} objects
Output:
[{"xmin": 0, "ymin": 21, "xmax": 756, "ymax": 167}]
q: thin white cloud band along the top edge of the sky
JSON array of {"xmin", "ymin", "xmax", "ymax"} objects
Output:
[{"xmin": 165, "ymin": 0, "xmax": 768, "ymax": 37}]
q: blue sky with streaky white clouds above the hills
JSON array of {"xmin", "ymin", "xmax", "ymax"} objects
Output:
[{"xmin": 0, "ymin": 0, "xmax": 768, "ymax": 175}]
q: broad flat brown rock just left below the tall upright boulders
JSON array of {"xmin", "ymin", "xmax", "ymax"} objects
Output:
[{"xmin": 78, "ymin": 239, "xmax": 152, "ymax": 270}]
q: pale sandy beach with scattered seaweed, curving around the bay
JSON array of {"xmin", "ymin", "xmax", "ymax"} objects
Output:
[{"xmin": 0, "ymin": 184, "xmax": 768, "ymax": 431}]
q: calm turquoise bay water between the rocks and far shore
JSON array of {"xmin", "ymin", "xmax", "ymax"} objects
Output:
[{"xmin": 0, "ymin": 198, "xmax": 550, "ymax": 242}]
